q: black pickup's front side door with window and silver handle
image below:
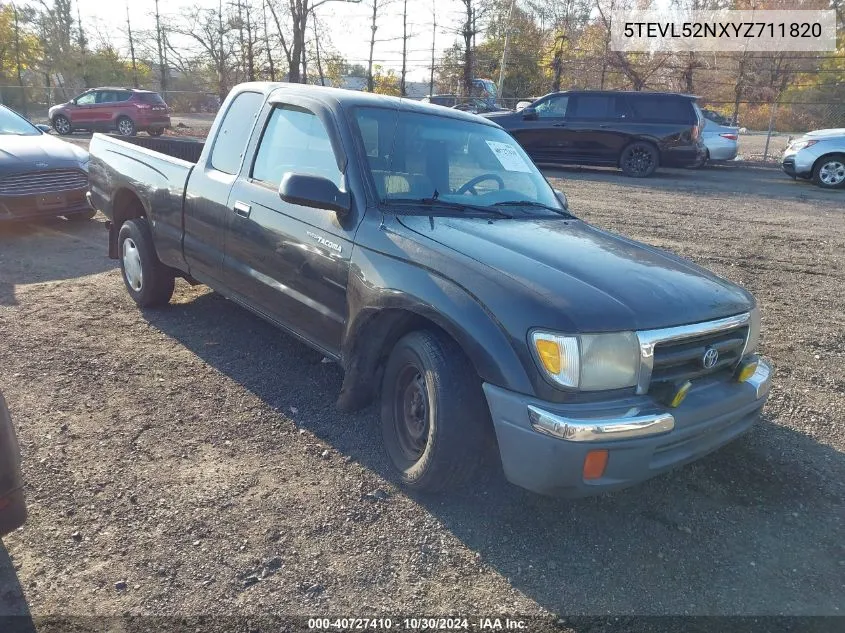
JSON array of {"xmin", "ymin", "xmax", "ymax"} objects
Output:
[{"xmin": 223, "ymin": 103, "xmax": 355, "ymax": 356}]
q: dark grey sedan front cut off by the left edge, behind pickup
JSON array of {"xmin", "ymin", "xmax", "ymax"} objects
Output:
[{"xmin": 0, "ymin": 105, "xmax": 95, "ymax": 222}]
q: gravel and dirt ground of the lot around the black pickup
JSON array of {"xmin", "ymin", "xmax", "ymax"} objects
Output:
[{"xmin": 0, "ymin": 168, "xmax": 845, "ymax": 620}]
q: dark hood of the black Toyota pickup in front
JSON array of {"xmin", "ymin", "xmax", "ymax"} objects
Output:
[{"xmin": 400, "ymin": 216, "xmax": 754, "ymax": 332}]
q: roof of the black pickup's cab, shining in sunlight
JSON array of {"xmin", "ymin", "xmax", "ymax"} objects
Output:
[{"xmin": 235, "ymin": 81, "xmax": 499, "ymax": 127}]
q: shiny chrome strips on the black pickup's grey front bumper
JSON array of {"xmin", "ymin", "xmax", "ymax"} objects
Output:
[{"xmin": 528, "ymin": 359, "xmax": 772, "ymax": 442}]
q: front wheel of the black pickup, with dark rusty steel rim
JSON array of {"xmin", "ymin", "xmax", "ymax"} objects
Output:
[{"xmin": 381, "ymin": 330, "xmax": 489, "ymax": 492}]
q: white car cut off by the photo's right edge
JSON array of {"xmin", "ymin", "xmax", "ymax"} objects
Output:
[{"xmin": 781, "ymin": 128, "xmax": 845, "ymax": 189}]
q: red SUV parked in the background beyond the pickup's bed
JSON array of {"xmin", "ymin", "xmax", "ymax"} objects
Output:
[{"xmin": 48, "ymin": 88, "xmax": 170, "ymax": 136}]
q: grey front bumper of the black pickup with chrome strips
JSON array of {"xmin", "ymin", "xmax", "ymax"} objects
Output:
[{"xmin": 484, "ymin": 359, "xmax": 771, "ymax": 497}]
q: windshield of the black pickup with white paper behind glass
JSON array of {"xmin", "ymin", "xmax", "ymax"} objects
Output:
[{"xmin": 356, "ymin": 108, "xmax": 562, "ymax": 210}]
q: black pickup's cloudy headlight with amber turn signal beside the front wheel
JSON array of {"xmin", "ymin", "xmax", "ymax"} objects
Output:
[{"xmin": 531, "ymin": 331, "xmax": 640, "ymax": 391}]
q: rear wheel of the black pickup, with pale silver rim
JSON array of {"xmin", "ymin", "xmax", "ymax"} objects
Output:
[{"xmin": 117, "ymin": 218, "xmax": 176, "ymax": 308}]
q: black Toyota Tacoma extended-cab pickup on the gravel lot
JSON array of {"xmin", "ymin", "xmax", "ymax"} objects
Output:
[{"xmin": 89, "ymin": 83, "xmax": 770, "ymax": 496}]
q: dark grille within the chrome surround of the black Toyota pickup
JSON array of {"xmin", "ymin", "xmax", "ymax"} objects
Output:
[{"xmin": 651, "ymin": 326, "xmax": 748, "ymax": 384}]
